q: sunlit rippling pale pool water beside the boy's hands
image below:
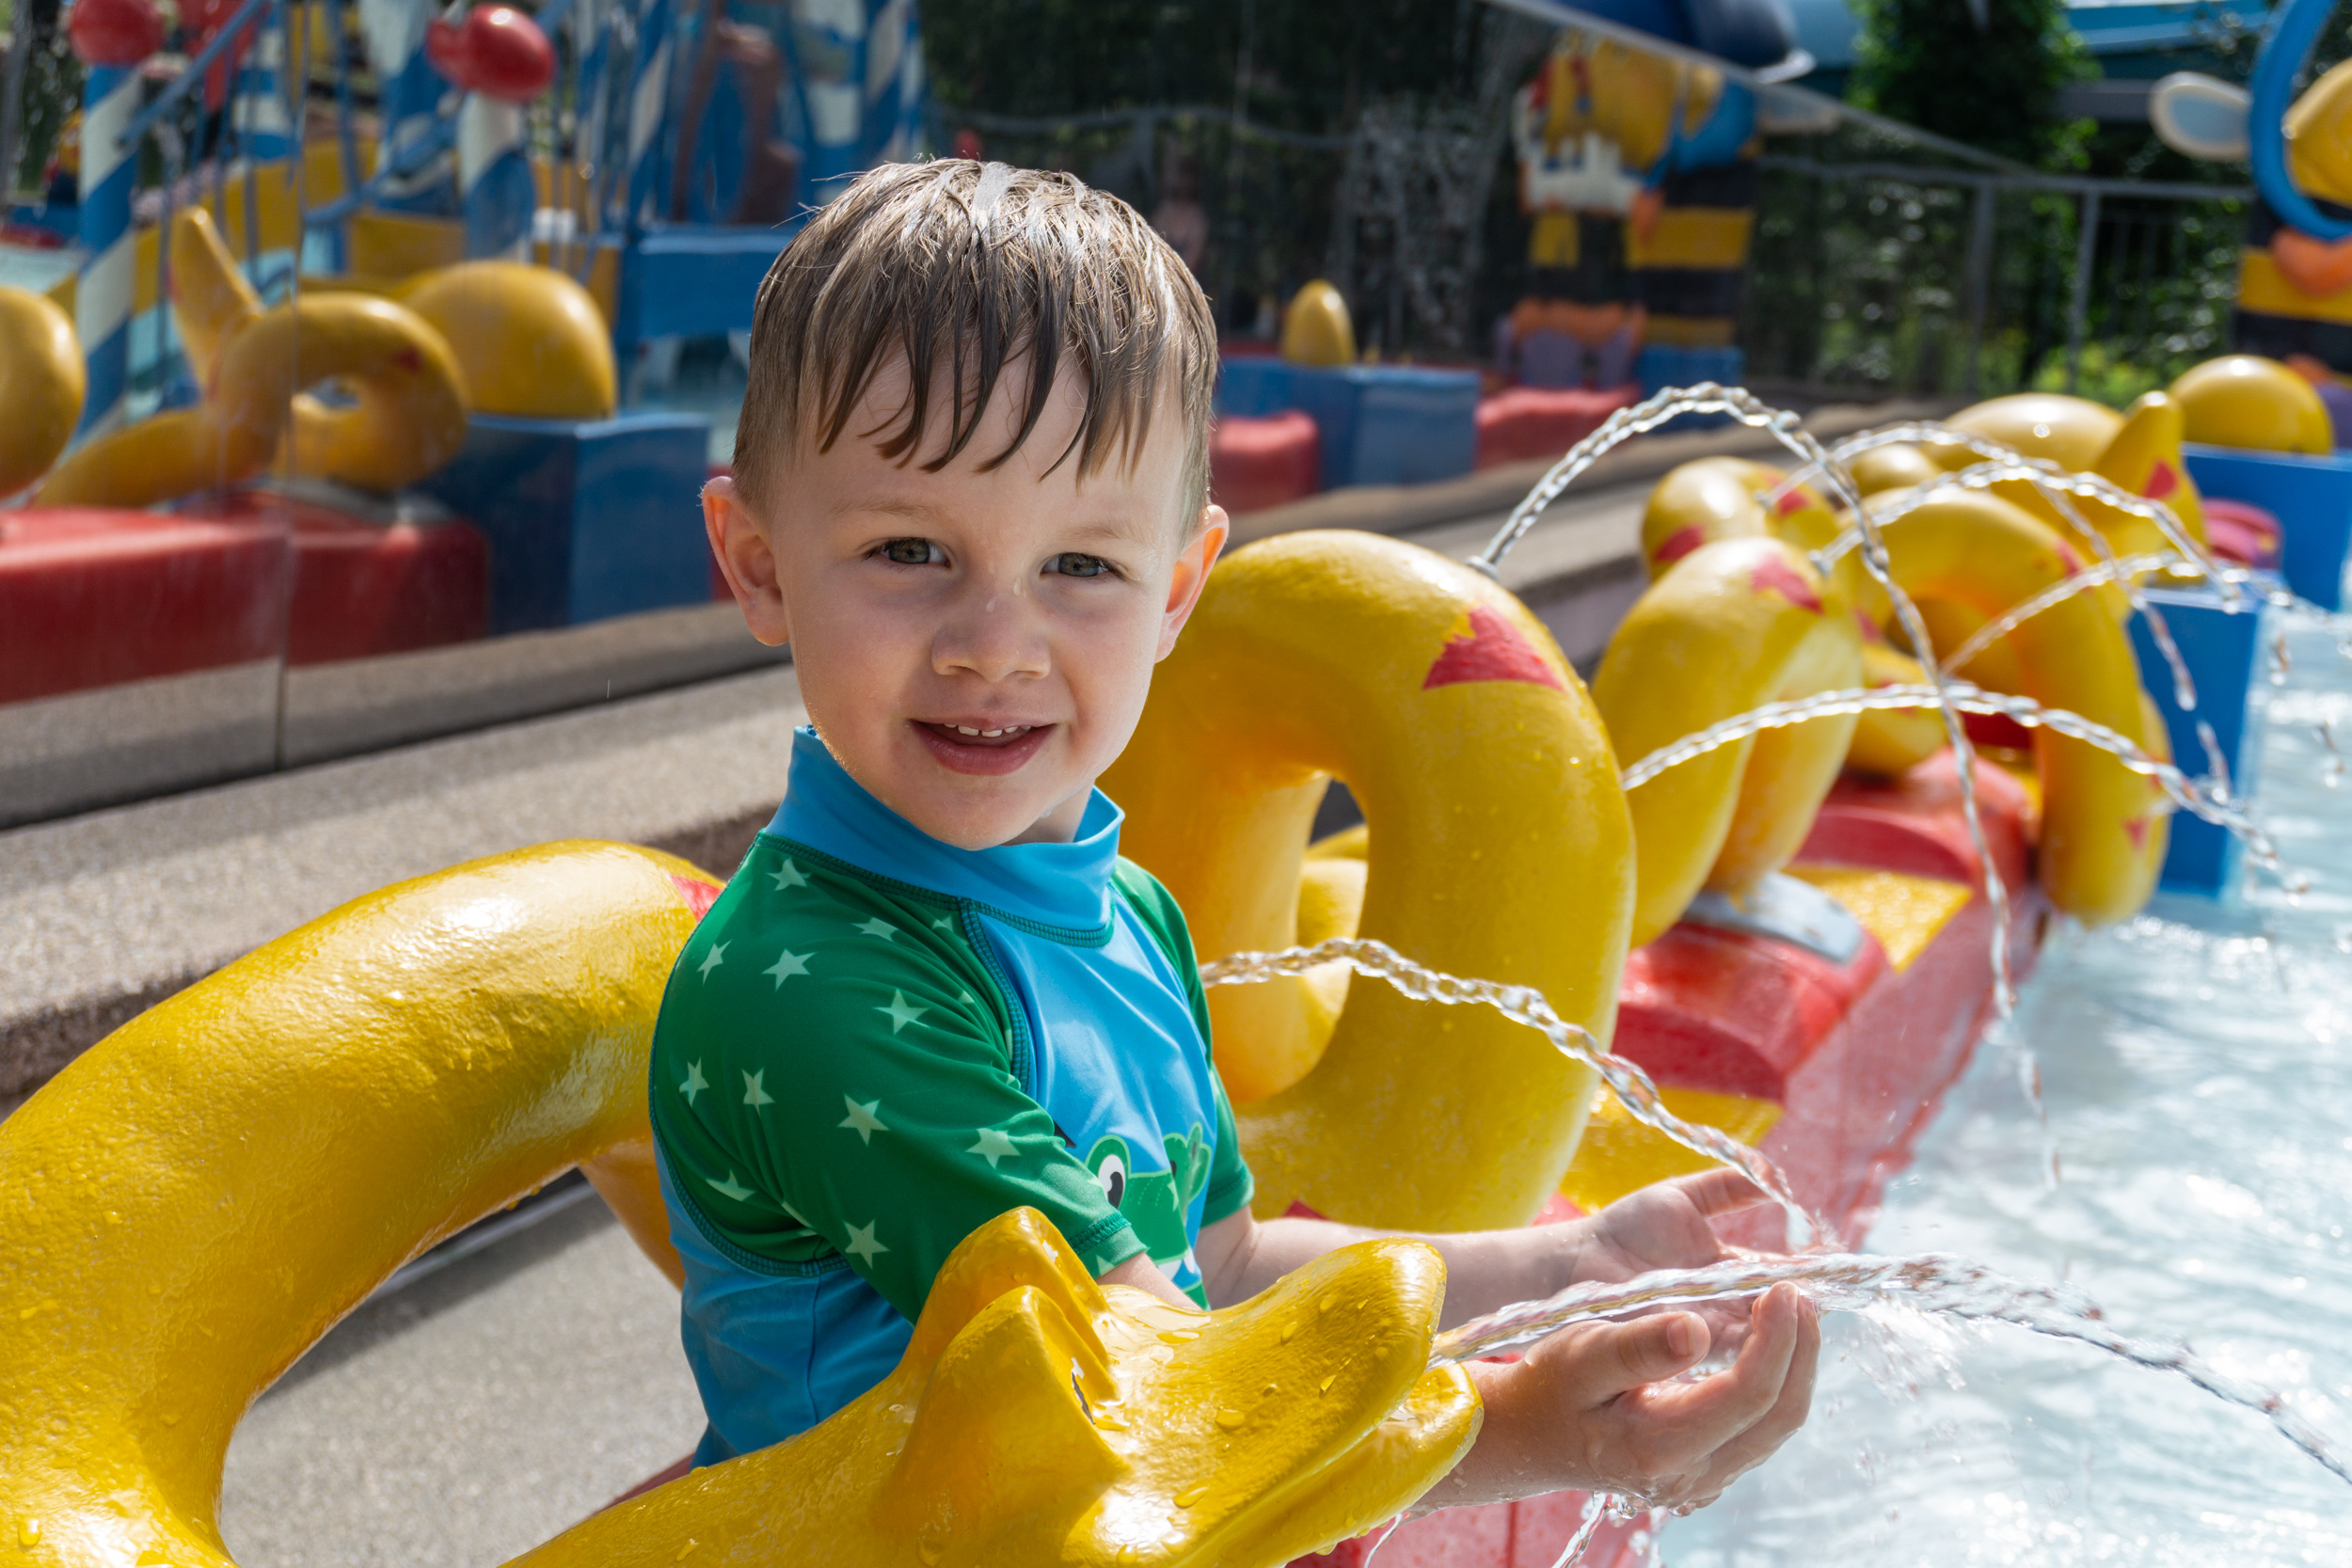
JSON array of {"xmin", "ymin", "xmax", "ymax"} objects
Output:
[{"xmin": 1663, "ymin": 615, "xmax": 2352, "ymax": 1568}]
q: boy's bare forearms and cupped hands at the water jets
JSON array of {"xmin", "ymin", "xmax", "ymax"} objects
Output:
[{"xmin": 1198, "ymin": 1171, "xmax": 1820, "ymax": 1510}]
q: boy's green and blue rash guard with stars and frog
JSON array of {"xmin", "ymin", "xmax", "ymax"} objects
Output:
[{"xmin": 649, "ymin": 729, "xmax": 1251, "ymax": 1463}]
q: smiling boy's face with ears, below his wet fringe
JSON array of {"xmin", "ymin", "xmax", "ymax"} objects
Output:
[{"xmin": 704, "ymin": 359, "xmax": 1226, "ymax": 848}]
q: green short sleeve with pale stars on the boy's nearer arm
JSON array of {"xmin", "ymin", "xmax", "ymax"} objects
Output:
[{"xmin": 652, "ymin": 861, "xmax": 1143, "ymax": 1322}]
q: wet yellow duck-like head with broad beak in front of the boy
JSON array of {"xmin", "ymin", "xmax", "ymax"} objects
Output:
[{"xmin": 536, "ymin": 1209, "xmax": 1480, "ymax": 1568}]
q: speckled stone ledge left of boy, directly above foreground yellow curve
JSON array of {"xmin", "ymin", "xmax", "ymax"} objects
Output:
[{"xmin": 0, "ymin": 665, "xmax": 803, "ymax": 1112}]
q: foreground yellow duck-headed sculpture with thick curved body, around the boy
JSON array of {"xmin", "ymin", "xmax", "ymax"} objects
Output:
[{"xmin": 0, "ymin": 844, "xmax": 1480, "ymax": 1568}]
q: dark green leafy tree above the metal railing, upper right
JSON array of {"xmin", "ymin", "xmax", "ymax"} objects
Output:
[{"xmin": 1847, "ymin": 0, "xmax": 2098, "ymax": 166}]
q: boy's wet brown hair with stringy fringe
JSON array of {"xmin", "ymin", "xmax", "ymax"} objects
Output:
[{"xmin": 734, "ymin": 160, "xmax": 1216, "ymax": 533}]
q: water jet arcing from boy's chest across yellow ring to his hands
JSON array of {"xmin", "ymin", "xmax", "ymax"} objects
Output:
[{"xmin": 1200, "ymin": 936, "xmax": 1837, "ymax": 1239}]
